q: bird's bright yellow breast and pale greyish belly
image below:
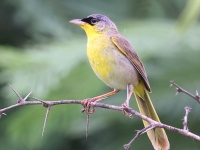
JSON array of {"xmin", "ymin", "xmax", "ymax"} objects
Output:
[{"xmin": 87, "ymin": 41, "xmax": 139, "ymax": 89}]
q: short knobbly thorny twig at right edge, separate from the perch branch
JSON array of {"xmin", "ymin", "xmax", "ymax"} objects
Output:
[{"xmin": 170, "ymin": 81, "xmax": 200, "ymax": 103}]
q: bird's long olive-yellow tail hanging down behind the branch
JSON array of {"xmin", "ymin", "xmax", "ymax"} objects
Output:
[{"xmin": 134, "ymin": 84, "xmax": 170, "ymax": 150}]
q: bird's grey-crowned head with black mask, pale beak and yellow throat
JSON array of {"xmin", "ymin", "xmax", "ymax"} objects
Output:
[{"xmin": 70, "ymin": 14, "xmax": 118, "ymax": 36}]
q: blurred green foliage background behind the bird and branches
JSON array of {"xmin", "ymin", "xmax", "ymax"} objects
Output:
[{"xmin": 0, "ymin": 0, "xmax": 200, "ymax": 150}]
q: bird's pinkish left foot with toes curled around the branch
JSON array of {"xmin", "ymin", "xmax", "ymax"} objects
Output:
[{"xmin": 81, "ymin": 98, "xmax": 95, "ymax": 115}]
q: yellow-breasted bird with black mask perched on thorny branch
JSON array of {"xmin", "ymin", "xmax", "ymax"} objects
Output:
[{"xmin": 69, "ymin": 14, "xmax": 170, "ymax": 150}]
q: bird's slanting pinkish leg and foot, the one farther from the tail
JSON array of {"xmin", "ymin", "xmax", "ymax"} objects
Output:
[{"xmin": 81, "ymin": 89, "xmax": 120, "ymax": 114}]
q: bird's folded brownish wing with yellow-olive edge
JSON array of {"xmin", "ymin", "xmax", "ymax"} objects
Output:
[{"xmin": 111, "ymin": 35, "xmax": 151, "ymax": 92}]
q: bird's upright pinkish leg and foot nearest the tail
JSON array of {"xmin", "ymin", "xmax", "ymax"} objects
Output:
[{"xmin": 122, "ymin": 84, "xmax": 134, "ymax": 117}]
